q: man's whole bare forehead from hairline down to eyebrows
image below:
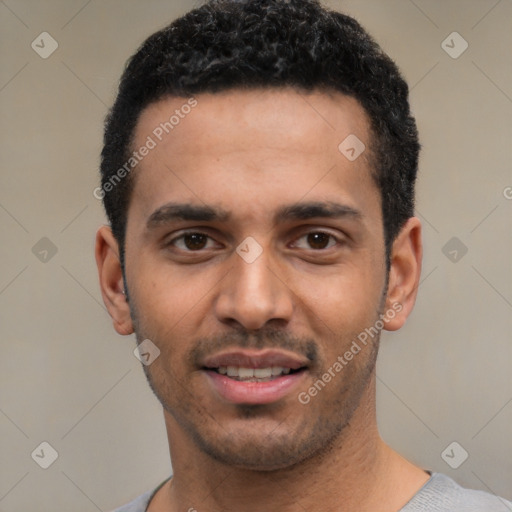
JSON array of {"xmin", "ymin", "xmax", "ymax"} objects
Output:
[{"xmin": 130, "ymin": 89, "xmax": 380, "ymax": 229}]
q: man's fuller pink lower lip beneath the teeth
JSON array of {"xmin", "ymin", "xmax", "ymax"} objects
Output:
[{"xmin": 205, "ymin": 370, "xmax": 306, "ymax": 404}]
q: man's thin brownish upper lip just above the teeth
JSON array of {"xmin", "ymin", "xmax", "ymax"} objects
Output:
[{"xmin": 203, "ymin": 349, "xmax": 309, "ymax": 370}]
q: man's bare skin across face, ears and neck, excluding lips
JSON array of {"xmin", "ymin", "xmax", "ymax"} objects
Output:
[{"xmin": 96, "ymin": 89, "xmax": 428, "ymax": 512}]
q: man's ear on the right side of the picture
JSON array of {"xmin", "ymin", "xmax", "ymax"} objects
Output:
[{"xmin": 384, "ymin": 217, "xmax": 423, "ymax": 331}]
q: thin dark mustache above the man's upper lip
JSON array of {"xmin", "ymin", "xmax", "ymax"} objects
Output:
[{"xmin": 189, "ymin": 328, "xmax": 318, "ymax": 366}]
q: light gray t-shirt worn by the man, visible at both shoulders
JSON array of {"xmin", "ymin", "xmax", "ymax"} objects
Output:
[{"xmin": 114, "ymin": 473, "xmax": 512, "ymax": 512}]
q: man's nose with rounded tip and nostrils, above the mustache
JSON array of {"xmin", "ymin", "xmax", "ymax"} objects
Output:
[{"xmin": 214, "ymin": 246, "xmax": 294, "ymax": 330}]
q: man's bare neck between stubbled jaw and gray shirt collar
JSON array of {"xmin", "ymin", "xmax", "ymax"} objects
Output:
[{"xmin": 149, "ymin": 372, "xmax": 428, "ymax": 512}]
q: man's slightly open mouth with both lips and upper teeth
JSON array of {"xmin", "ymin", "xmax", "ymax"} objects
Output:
[{"xmin": 201, "ymin": 350, "xmax": 309, "ymax": 404}]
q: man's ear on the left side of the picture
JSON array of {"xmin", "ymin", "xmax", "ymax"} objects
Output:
[{"xmin": 95, "ymin": 226, "xmax": 134, "ymax": 335}]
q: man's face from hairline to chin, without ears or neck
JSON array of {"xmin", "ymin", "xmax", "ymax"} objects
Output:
[{"xmin": 125, "ymin": 90, "xmax": 386, "ymax": 469}]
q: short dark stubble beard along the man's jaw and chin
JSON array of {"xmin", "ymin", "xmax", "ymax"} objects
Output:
[{"xmin": 132, "ymin": 331, "xmax": 380, "ymax": 471}]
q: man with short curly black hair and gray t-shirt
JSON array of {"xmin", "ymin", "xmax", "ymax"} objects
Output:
[{"xmin": 96, "ymin": 0, "xmax": 509, "ymax": 512}]
